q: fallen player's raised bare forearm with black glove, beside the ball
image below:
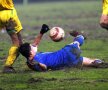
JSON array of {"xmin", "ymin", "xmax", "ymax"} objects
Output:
[{"xmin": 32, "ymin": 24, "xmax": 49, "ymax": 47}]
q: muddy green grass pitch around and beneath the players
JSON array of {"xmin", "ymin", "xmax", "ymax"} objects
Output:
[{"xmin": 0, "ymin": 0, "xmax": 108, "ymax": 90}]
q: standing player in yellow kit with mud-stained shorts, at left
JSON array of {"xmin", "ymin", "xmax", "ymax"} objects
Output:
[{"xmin": 0, "ymin": 0, "xmax": 22, "ymax": 73}]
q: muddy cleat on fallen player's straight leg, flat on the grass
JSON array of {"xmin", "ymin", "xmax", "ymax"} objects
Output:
[{"xmin": 92, "ymin": 59, "xmax": 108, "ymax": 68}]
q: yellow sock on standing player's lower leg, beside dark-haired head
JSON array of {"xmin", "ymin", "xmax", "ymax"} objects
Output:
[{"xmin": 5, "ymin": 46, "xmax": 18, "ymax": 66}]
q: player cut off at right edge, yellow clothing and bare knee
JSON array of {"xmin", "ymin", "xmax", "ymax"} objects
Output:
[{"xmin": 100, "ymin": 0, "xmax": 108, "ymax": 30}]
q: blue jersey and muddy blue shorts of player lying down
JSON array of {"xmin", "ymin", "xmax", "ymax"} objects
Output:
[{"xmin": 34, "ymin": 43, "xmax": 83, "ymax": 69}]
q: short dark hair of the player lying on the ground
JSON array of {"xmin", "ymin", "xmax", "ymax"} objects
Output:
[{"xmin": 19, "ymin": 43, "xmax": 31, "ymax": 59}]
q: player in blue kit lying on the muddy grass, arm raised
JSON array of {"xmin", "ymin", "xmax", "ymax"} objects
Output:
[{"xmin": 19, "ymin": 24, "xmax": 106, "ymax": 71}]
